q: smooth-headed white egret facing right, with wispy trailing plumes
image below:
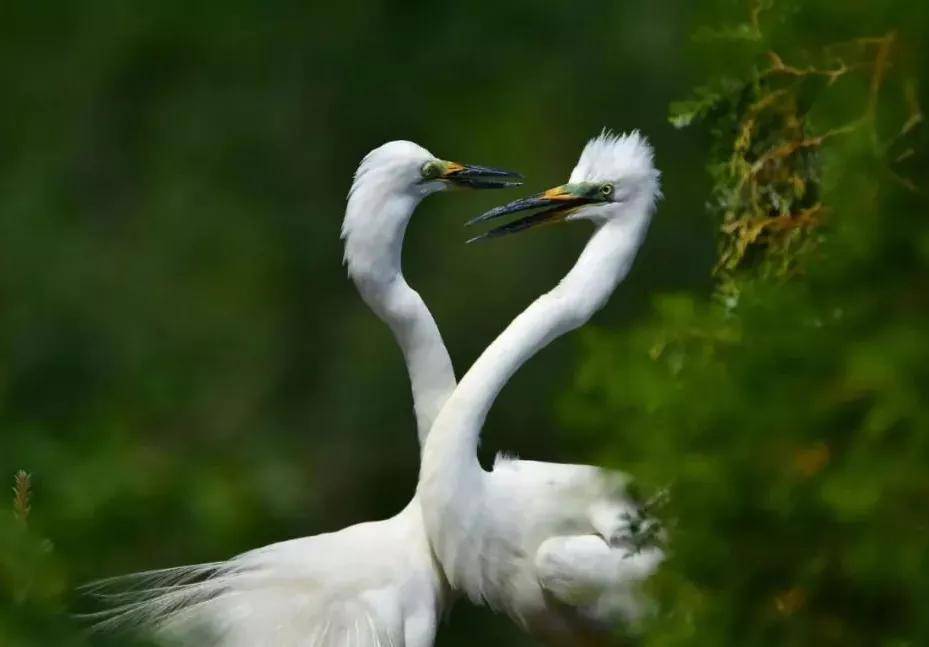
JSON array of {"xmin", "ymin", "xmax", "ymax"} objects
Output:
[{"xmin": 85, "ymin": 141, "xmax": 519, "ymax": 647}]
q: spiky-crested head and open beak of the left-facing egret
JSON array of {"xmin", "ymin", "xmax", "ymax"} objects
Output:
[{"xmin": 468, "ymin": 130, "xmax": 661, "ymax": 242}]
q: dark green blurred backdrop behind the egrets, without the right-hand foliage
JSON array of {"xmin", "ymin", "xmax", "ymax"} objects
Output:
[{"xmin": 0, "ymin": 1, "xmax": 712, "ymax": 644}]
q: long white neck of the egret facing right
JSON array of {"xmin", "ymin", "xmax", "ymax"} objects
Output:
[{"xmin": 343, "ymin": 187, "xmax": 455, "ymax": 445}]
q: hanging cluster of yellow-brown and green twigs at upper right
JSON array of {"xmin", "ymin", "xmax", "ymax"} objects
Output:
[{"xmin": 669, "ymin": 24, "xmax": 923, "ymax": 297}]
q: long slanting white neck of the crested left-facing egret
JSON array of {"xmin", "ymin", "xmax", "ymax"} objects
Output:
[{"xmin": 420, "ymin": 208, "xmax": 650, "ymax": 498}]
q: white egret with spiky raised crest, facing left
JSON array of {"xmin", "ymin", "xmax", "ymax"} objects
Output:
[{"xmin": 418, "ymin": 131, "xmax": 662, "ymax": 645}]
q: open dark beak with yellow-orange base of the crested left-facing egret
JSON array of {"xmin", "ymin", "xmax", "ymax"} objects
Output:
[{"xmin": 466, "ymin": 183, "xmax": 604, "ymax": 243}]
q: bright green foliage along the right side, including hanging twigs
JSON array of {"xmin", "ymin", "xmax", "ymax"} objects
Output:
[{"xmin": 561, "ymin": 2, "xmax": 929, "ymax": 646}]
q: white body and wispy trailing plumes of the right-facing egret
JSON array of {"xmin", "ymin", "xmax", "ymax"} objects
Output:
[{"xmin": 85, "ymin": 513, "xmax": 432, "ymax": 647}]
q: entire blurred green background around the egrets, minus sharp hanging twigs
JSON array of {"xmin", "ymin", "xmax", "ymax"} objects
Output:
[{"xmin": 0, "ymin": 0, "xmax": 929, "ymax": 646}]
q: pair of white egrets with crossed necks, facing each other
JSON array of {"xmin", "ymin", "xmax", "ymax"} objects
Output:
[{"xmin": 89, "ymin": 131, "xmax": 662, "ymax": 647}]
